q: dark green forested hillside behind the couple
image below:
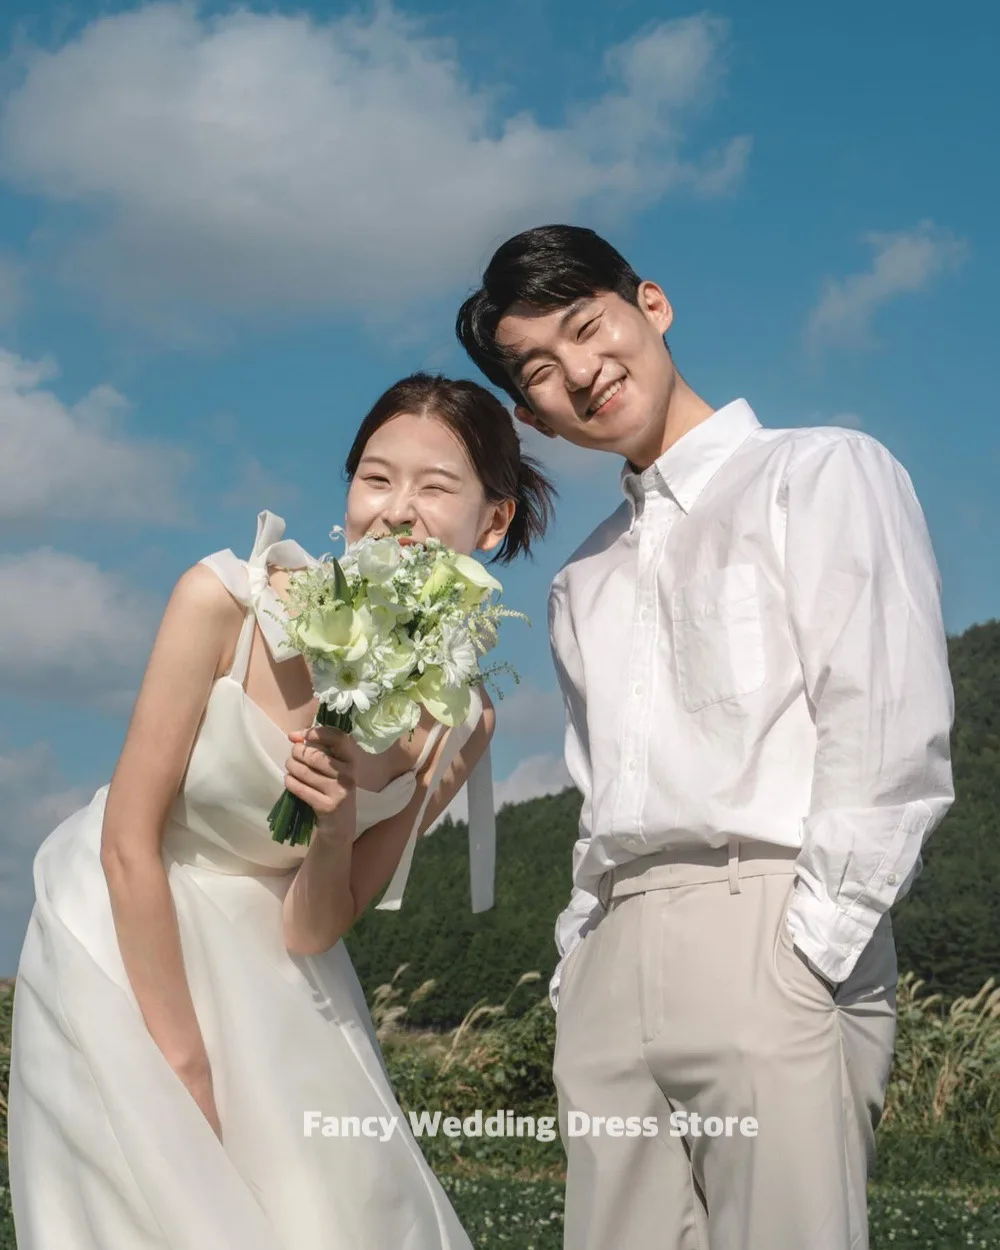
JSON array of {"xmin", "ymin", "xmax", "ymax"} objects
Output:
[{"xmin": 348, "ymin": 621, "xmax": 1000, "ymax": 1028}]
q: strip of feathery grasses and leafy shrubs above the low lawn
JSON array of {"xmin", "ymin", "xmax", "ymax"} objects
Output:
[{"xmin": 375, "ymin": 974, "xmax": 1000, "ymax": 1184}]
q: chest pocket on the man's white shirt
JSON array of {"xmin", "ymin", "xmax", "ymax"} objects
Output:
[{"xmin": 670, "ymin": 564, "xmax": 765, "ymax": 711}]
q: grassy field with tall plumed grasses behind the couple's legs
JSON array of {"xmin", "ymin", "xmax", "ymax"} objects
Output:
[{"xmin": 0, "ymin": 976, "xmax": 1000, "ymax": 1250}]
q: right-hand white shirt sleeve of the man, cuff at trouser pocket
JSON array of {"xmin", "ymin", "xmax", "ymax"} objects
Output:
[{"xmin": 779, "ymin": 431, "xmax": 954, "ymax": 983}]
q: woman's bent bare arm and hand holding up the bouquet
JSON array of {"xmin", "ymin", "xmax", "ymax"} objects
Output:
[{"xmin": 285, "ymin": 690, "xmax": 496, "ymax": 955}]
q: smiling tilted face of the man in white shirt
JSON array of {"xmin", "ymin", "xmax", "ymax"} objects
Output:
[{"xmin": 496, "ymin": 283, "xmax": 675, "ymax": 466}]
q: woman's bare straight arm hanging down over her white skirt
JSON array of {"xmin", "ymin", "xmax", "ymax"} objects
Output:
[{"xmin": 101, "ymin": 565, "xmax": 243, "ymax": 1131}]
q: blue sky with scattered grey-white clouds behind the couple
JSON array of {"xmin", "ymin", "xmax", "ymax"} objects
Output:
[{"xmin": 0, "ymin": 0, "xmax": 1000, "ymax": 973}]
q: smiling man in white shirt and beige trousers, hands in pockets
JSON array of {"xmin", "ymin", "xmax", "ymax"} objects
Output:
[{"xmin": 458, "ymin": 226, "xmax": 954, "ymax": 1250}]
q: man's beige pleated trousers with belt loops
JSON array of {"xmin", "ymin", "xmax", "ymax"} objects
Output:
[{"xmin": 554, "ymin": 843, "xmax": 896, "ymax": 1250}]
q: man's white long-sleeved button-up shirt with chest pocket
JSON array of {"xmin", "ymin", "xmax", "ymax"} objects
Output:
[{"xmin": 549, "ymin": 400, "xmax": 954, "ymax": 1006}]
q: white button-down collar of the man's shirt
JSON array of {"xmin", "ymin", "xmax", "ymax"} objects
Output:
[{"xmin": 621, "ymin": 399, "xmax": 760, "ymax": 530}]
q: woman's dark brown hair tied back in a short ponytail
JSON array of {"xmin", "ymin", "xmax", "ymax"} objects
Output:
[{"xmin": 344, "ymin": 373, "xmax": 559, "ymax": 564}]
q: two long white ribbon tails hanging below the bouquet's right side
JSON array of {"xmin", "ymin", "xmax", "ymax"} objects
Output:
[{"xmin": 376, "ymin": 689, "xmax": 496, "ymax": 913}]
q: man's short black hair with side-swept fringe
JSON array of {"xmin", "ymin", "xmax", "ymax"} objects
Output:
[{"xmin": 455, "ymin": 226, "xmax": 641, "ymax": 404}]
